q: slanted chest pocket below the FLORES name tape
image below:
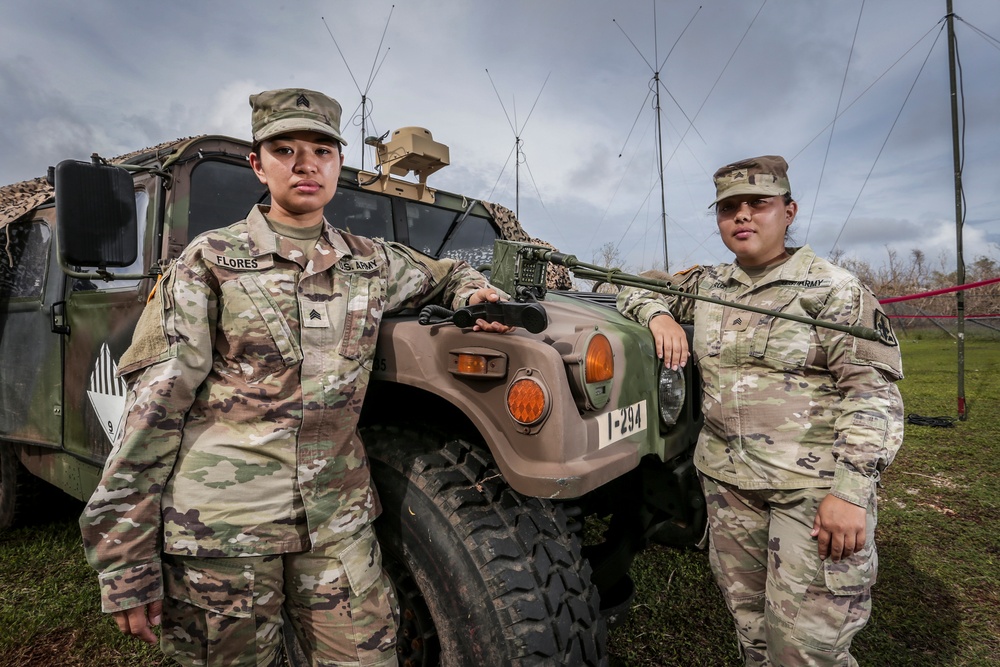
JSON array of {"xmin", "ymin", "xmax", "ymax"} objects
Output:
[{"xmin": 222, "ymin": 274, "xmax": 302, "ymax": 382}]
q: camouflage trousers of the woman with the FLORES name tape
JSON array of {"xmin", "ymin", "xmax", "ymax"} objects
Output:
[{"xmin": 160, "ymin": 526, "xmax": 399, "ymax": 667}]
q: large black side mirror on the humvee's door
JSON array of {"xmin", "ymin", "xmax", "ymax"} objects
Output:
[{"xmin": 55, "ymin": 160, "xmax": 138, "ymax": 268}]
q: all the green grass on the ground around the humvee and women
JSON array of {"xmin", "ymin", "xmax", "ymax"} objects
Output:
[{"xmin": 0, "ymin": 337, "xmax": 1000, "ymax": 667}]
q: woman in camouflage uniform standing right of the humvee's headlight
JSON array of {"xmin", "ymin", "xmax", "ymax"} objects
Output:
[{"xmin": 618, "ymin": 156, "xmax": 903, "ymax": 666}]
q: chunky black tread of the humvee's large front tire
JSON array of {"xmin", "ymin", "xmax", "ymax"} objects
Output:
[{"xmin": 365, "ymin": 426, "xmax": 607, "ymax": 666}]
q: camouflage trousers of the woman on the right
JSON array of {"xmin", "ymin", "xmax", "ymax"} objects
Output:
[{"xmin": 702, "ymin": 475, "xmax": 878, "ymax": 667}]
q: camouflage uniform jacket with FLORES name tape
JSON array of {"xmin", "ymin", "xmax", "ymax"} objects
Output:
[{"xmin": 80, "ymin": 207, "xmax": 496, "ymax": 611}]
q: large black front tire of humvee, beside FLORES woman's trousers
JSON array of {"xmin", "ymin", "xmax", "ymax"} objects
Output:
[{"xmin": 362, "ymin": 426, "xmax": 608, "ymax": 667}]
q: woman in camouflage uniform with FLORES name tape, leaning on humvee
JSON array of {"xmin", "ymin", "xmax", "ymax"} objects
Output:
[{"xmin": 80, "ymin": 89, "xmax": 506, "ymax": 666}]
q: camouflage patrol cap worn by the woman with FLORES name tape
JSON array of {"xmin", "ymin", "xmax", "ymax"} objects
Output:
[{"xmin": 250, "ymin": 88, "xmax": 347, "ymax": 146}]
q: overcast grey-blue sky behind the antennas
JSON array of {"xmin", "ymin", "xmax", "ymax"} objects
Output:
[{"xmin": 0, "ymin": 0, "xmax": 1000, "ymax": 270}]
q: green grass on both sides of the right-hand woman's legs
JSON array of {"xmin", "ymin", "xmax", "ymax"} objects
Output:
[{"xmin": 611, "ymin": 336, "xmax": 1000, "ymax": 667}]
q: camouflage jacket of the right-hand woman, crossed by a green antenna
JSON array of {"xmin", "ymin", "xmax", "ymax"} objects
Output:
[{"xmin": 618, "ymin": 246, "xmax": 903, "ymax": 506}]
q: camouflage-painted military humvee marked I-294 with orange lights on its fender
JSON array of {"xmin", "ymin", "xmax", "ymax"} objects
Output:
[{"xmin": 0, "ymin": 128, "xmax": 705, "ymax": 665}]
